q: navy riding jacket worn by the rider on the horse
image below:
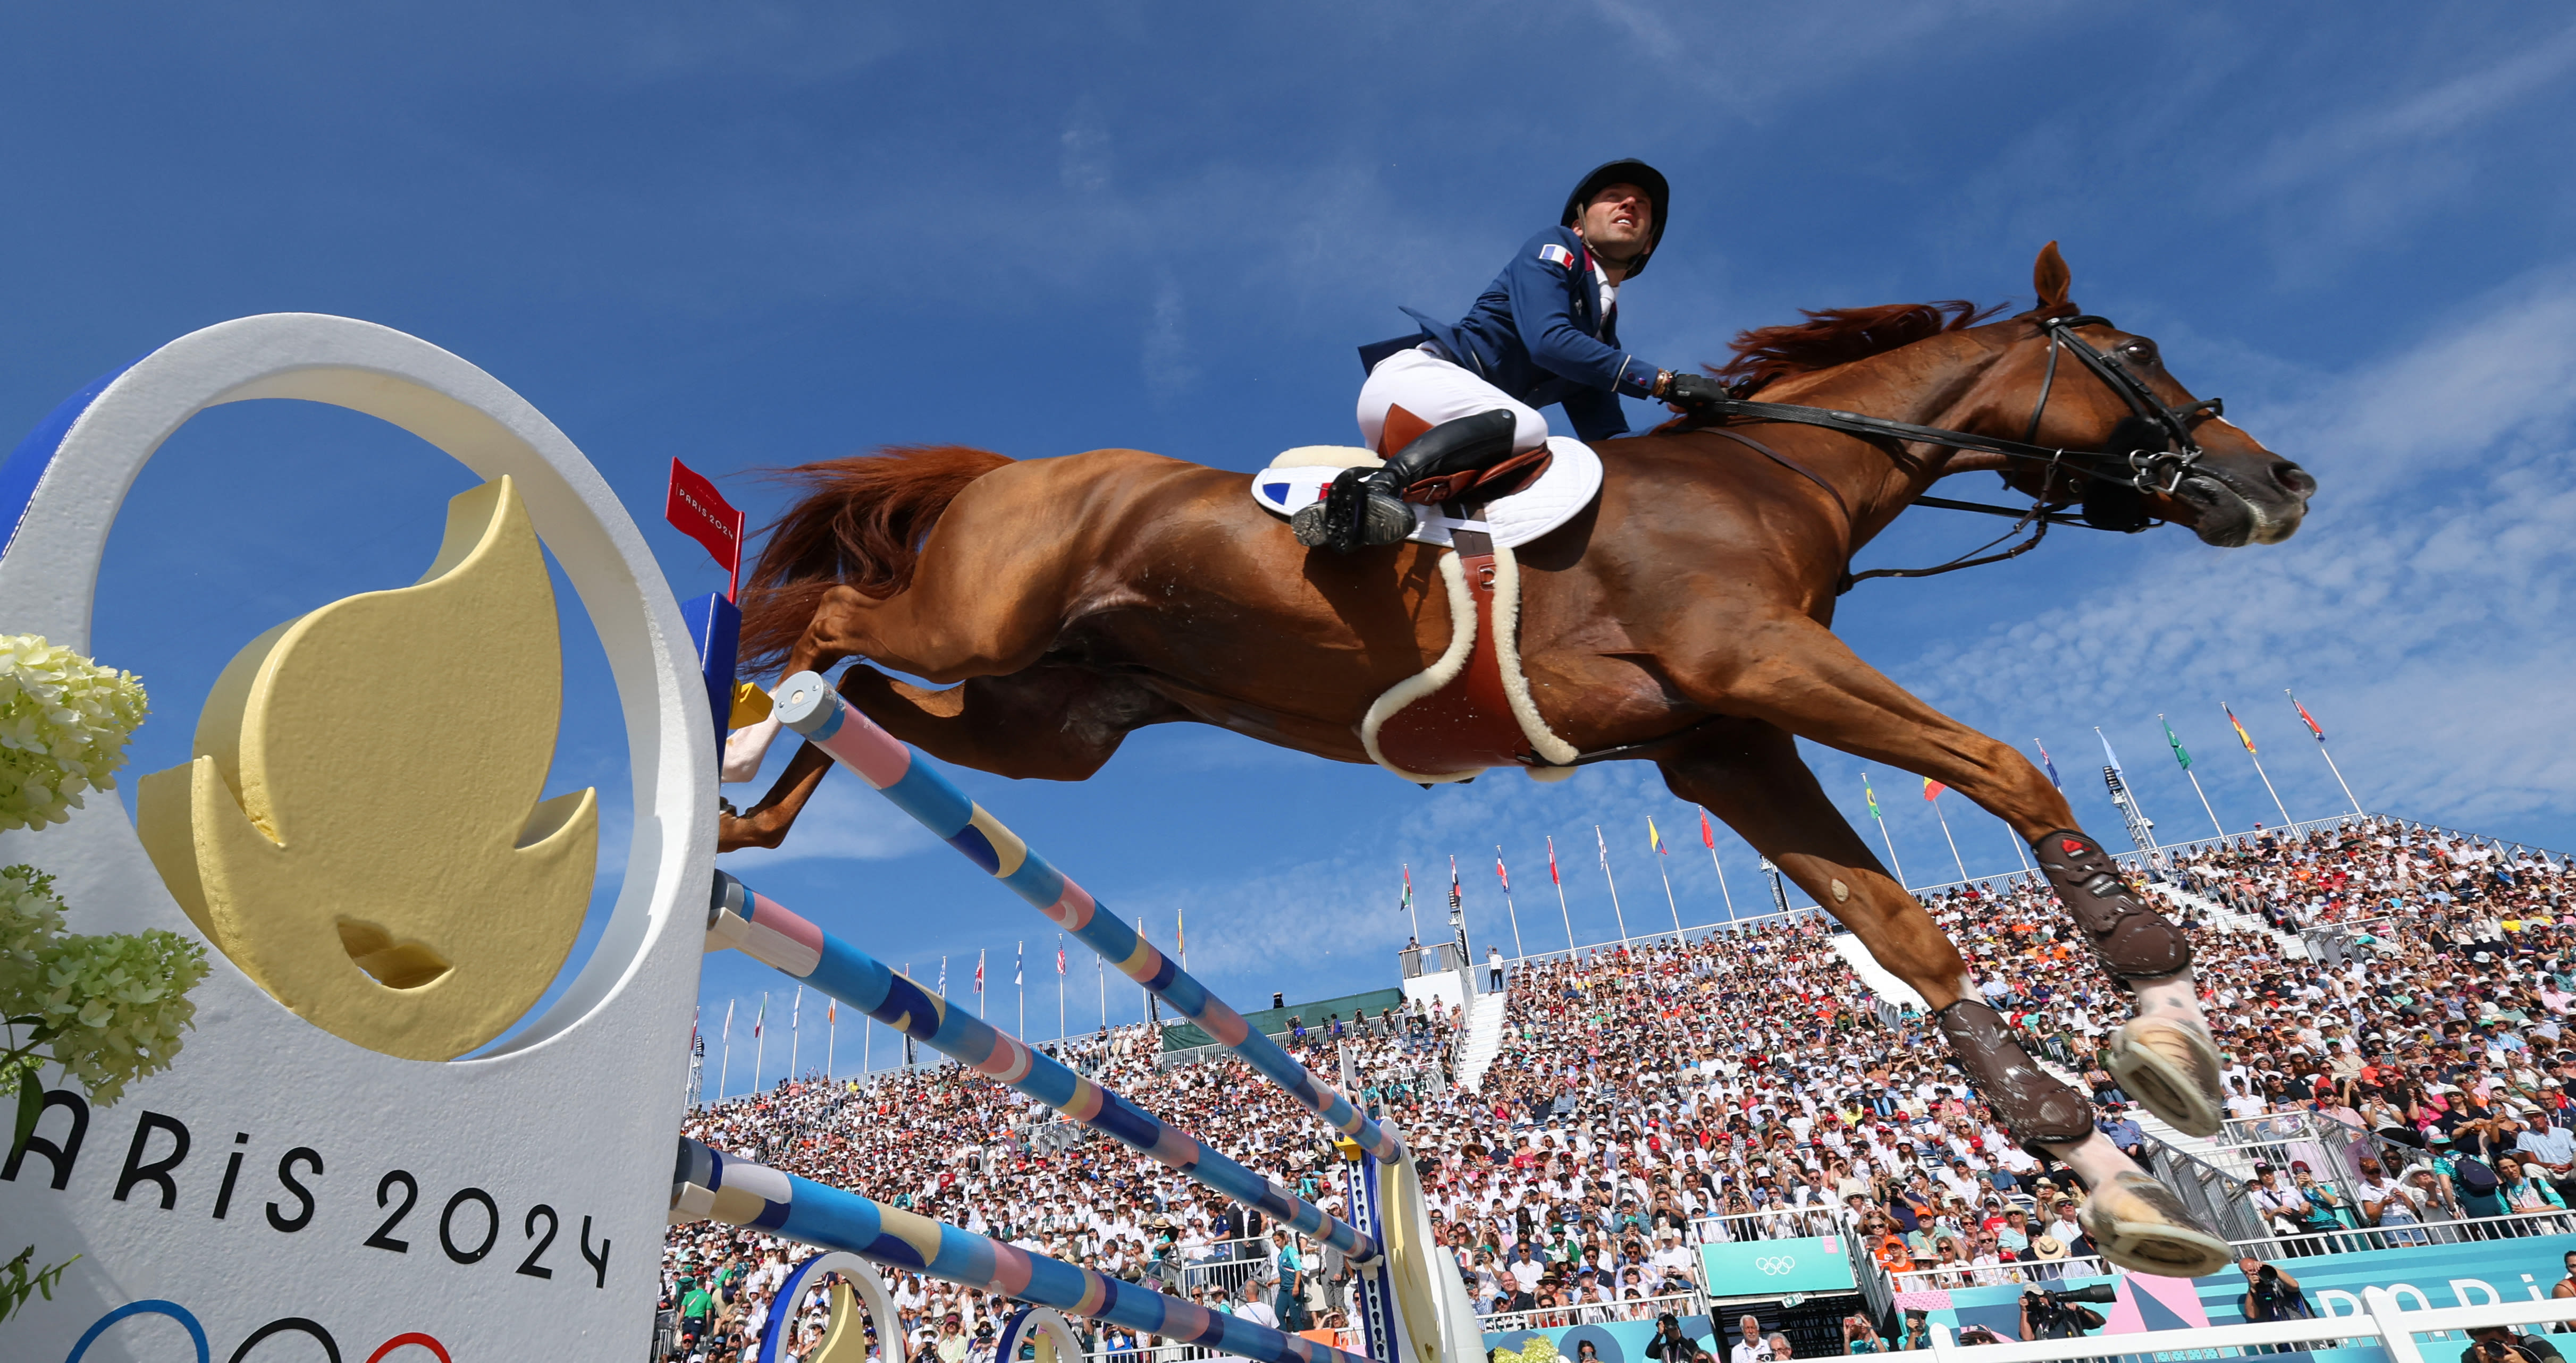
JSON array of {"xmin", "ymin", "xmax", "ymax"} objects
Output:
[{"xmin": 1363, "ymin": 227, "xmax": 1656, "ymax": 441}]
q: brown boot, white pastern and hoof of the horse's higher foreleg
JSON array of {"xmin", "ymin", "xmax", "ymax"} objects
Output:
[{"xmin": 2032, "ymin": 829, "xmax": 2226, "ymax": 1136}]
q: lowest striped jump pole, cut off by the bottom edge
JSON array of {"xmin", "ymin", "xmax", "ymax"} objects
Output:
[{"xmin": 670, "ymin": 1136, "xmax": 1368, "ymax": 1363}]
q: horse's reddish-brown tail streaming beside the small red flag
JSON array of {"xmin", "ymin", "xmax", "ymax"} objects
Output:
[{"xmin": 742, "ymin": 446, "xmax": 1010, "ymax": 675}]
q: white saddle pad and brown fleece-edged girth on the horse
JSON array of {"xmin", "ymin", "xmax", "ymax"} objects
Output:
[{"xmin": 1252, "ymin": 425, "xmax": 1602, "ymax": 786}]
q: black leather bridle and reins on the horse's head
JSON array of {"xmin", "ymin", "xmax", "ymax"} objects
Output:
[{"xmin": 1693, "ymin": 315, "xmax": 2226, "ymax": 595}]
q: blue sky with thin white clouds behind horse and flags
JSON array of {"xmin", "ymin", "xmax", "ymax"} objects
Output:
[{"xmin": 0, "ymin": 3, "xmax": 2576, "ymax": 1082}]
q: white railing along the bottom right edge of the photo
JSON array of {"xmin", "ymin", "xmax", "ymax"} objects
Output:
[{"xmin": 1930, "ymin": 1288, "xmax": 2576, "ymax": 1363}]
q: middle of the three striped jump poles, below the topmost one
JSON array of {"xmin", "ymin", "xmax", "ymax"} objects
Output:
[{"xmin": 706, "ymin": 871, "xmax": 1378, "ymax": 1265}]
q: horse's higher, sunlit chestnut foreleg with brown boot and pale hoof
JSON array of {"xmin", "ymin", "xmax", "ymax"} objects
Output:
[{"xmin": 1674, "ymin": 616, "xmax": 2223, "ymax": 1136}]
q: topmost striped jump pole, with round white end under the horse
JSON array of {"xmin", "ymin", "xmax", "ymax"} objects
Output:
[{"xmin": 770, "ymin": 673, "xmax": 1404, "ymax": 1165}]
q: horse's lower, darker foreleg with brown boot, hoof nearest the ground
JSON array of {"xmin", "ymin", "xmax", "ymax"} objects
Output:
[{"xmin": 1662, "ymin": 722, "xmax": 2228, "ymax": 1278}]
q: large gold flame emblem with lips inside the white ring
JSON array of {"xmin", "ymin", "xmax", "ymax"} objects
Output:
[{"xmin": 134, "ymin": 477, "xmax": 600, "ymax": 1059}]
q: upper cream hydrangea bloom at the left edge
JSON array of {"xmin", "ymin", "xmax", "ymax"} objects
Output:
[{"xmin": 0, "ymin": 634, "xmax": 149, "ymax": 829}]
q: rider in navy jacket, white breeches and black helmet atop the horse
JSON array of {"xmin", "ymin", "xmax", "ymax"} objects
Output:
[{"xmin": 1291, "ymin": 160, "xmax": 1726, "ymax": 552}]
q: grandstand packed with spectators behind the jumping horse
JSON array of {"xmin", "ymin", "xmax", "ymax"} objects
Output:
[{"xmin": 664, "ymin": 814, "xmax": 2576, "ymax": 1363}]
